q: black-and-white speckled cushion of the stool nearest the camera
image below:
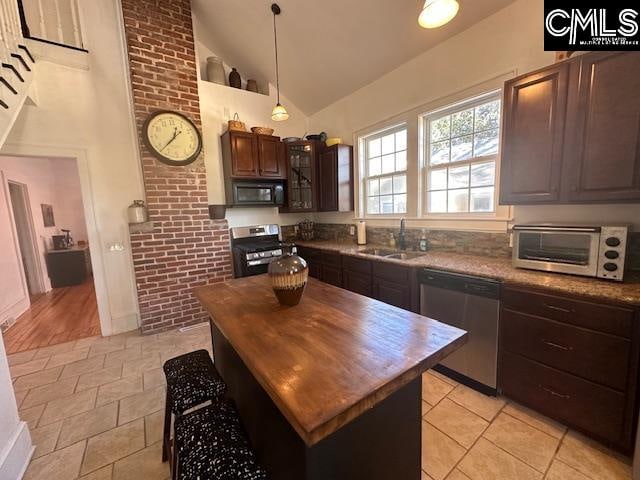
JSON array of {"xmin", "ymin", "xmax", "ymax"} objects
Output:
[{"xmin": 175, "ymin": 401, "xmax": 267, "ymax": 480}]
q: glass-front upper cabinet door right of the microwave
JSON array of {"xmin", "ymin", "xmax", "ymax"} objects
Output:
[{"xmin": 286, "ymin": 141, "xmax": 319, "ymax": 212}]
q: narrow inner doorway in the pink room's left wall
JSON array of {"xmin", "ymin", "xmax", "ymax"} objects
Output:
[{"xmin": 7, "ymin": 181, "xmax": 44, "ymax": 304}]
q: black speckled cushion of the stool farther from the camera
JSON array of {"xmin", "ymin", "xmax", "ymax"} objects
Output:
[{"xmin": 163, "ymin": 350, "xmax": 227, "ymax": 414}]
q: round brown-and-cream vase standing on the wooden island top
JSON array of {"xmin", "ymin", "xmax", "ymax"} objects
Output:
[{"xmin": 269, "ymin": 244, "xmax": 309, "ymax": 307}]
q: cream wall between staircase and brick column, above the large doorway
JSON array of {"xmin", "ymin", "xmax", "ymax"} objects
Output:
[{"xmin": 2, "ymin": 0, "xmax": 144, "ymax": 335}]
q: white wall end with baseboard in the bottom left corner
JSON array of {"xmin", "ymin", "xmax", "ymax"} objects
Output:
[{"xmin": 0, "ymin": 333, "xmax": 33, "ymax": 480}]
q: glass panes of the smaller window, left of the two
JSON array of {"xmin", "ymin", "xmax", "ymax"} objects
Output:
[{"xmin": 363, "ymin": 125, "xmax": 407, "ymax": 215}]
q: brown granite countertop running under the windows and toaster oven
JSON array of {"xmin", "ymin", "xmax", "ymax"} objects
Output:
[{"xmin": 295, "ymin": 240, "xmax": 640, "ymax": 306}]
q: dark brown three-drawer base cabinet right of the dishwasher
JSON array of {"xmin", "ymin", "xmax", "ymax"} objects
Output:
[{"xmin": 498, "ymin": 286, "xmax": 640, "ymax": 454}]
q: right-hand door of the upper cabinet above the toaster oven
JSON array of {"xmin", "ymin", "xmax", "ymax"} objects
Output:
[{"xmin": 563, "ymin": 52, "xmax": 640, "ymax": 203}]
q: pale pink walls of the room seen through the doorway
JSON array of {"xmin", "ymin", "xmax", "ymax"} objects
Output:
[{"xmin": 0, "ymin": 156, "xmax": 87, "ymax": 312}]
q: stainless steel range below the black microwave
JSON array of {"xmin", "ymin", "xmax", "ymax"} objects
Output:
[{"xmin": 231, "ymin": 224, "xmax": 296, "ymax": 277}]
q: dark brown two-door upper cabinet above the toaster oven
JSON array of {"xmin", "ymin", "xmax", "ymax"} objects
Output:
[{"xmin": 500, "ymin": 52, "xmax": 640, "ymax": 205}]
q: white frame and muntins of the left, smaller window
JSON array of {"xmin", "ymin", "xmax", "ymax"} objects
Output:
[{"xmin": 358, "ymin": 122, "xmax": 410, "ymax": 218}]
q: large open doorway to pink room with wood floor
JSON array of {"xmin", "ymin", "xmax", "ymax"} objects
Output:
[{"xmin": 0, "ymin": 156, "xmax": 101, "ymax": 354}]
